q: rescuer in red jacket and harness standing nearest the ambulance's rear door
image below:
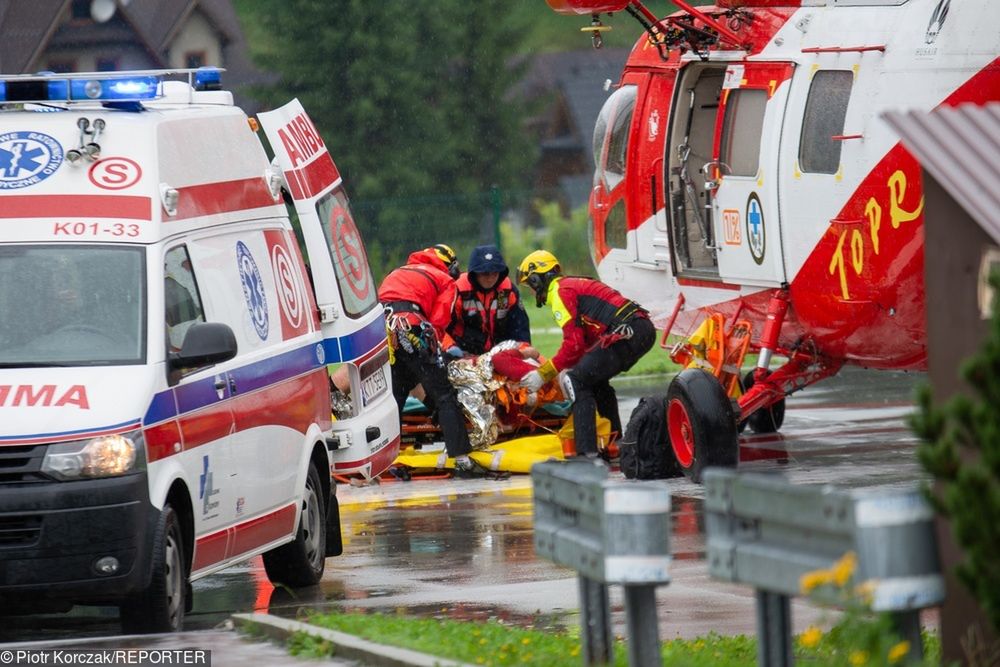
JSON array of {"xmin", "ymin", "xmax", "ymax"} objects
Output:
[{"xmin": 378, "ymin": 244, "xmax": 476, "ymax": 472}]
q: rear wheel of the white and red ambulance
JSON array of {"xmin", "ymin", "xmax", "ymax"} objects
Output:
[{"xmin": 264, "ymin": 464, "xmax": 326, "ymax": 588}]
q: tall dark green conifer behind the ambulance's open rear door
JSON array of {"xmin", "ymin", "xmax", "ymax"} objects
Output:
[{"xmin": 241, "ymin": 0, "xmax": 544, "ymax": 273}]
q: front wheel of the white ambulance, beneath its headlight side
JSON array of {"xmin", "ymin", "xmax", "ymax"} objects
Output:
[{"xmin": 120, "ymin": 503, "xmax": 191, "ymax": 634}]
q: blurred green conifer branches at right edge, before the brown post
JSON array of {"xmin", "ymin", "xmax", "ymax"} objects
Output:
[{"xmin": 910, "ymin": 274, "xmax": 1000, "ymax": 630}]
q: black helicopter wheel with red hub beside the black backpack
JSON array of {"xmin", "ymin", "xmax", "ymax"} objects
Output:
[{"xmin": 667, "ymin": 368, "xmax": 739, "ymax": 483}]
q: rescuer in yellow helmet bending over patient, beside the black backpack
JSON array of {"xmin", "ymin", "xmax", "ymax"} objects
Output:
[{"xmin": 517, "ymin": 250, "xmax": 656, "ymax": 456}]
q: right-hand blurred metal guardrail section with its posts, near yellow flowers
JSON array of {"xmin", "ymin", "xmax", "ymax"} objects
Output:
[{"xmin": 705, "ymin": 468, "xmax": 944, "ymax": 667}]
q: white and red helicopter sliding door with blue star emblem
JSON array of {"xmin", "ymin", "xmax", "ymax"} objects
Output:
[{"xmin": 707, "ymin": 61, "xmax": 795, "ymax": 287}]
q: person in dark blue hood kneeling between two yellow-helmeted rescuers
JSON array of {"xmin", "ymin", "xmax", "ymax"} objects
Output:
[{"xmin": 448, "ymin": 245, "xmax": 531, "ymax": 357}]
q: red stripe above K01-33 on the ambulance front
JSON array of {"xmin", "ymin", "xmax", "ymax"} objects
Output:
[{"xmin": 0, "ymin": 195, "xmax": 153, "ymax": 220}]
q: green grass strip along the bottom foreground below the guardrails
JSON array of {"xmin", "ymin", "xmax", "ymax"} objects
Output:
[{"xmin": 289, "ymin": 612, "xmax": 941, "ymax": 667}]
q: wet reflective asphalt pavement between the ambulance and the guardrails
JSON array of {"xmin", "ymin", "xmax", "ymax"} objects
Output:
[{"xmin": 0, "ymin": 369, "xmax": 933, "ymax": 667}]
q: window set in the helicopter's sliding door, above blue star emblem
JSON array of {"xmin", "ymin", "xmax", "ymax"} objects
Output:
[{"xmin": 719, "ymin": 88, "xmax": 767, "ymax": 176}]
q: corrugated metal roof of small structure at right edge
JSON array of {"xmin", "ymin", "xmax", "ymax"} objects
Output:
[{"xmin": 883, "ymin": 102, "xmax": 1000, "ymax": 244}]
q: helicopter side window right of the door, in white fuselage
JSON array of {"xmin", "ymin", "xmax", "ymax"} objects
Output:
[{"xmin": 799, "ymin": 70, "xmax": 854, "ymax": 174}]
